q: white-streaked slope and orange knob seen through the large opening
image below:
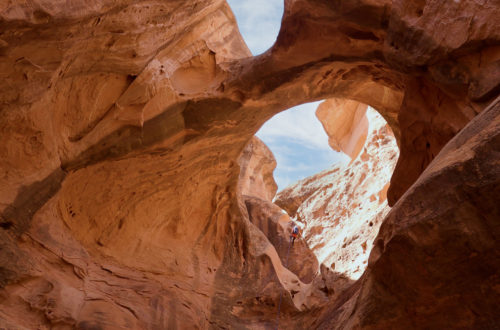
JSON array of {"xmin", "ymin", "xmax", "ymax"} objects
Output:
[{"xmin": 275, "ymin": 100, "xmax": 398, "ymax": 279}]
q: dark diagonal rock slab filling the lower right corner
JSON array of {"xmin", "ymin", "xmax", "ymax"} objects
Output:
[{"xmin": 315, "ymin": 94, "xmax": 500, "ymax": 329}]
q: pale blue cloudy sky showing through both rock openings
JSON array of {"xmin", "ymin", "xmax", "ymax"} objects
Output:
[{"xmin": 228, "ymin": 0, "xmax": 346, "ymax": 191}]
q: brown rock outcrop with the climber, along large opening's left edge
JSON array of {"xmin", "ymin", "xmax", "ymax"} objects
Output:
[{"xmin": 235, "ymin": 137, "xmax": 352, "ymax": 327}]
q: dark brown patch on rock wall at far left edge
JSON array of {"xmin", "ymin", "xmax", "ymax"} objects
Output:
[{"xmin": 0, "ymin": 168, "xmax": 66, "ymax": 236}]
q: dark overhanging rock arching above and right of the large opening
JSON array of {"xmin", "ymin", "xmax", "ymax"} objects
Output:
[{"xmin": 233, "ymin": 0, "xmax": 500, "ymax": 204}]
